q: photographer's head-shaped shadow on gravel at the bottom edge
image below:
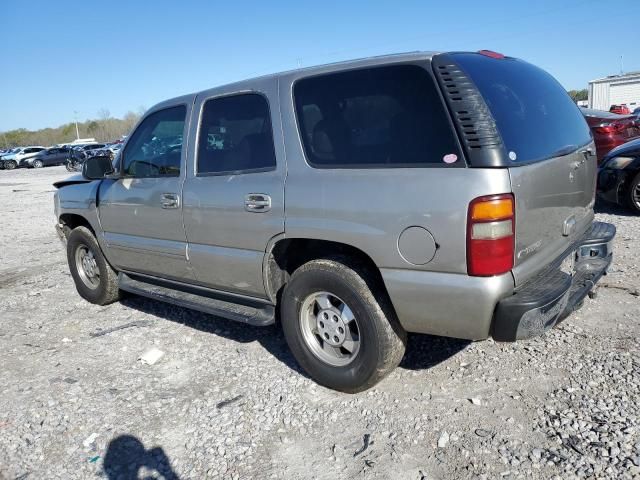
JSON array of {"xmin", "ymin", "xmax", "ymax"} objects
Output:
[{"xmin": 102, "ymin": 435, "xmax": 179, "ymax": 480}]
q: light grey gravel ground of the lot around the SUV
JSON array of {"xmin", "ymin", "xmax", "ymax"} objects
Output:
[{"xmin": 0, "ymin": 167, "xmax": 640, "ymax": 480}]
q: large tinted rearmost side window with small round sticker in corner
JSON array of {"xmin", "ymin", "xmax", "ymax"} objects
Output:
[{"xmin": 294, "ymin": 65, "xmax": 462, "ymax": 168}]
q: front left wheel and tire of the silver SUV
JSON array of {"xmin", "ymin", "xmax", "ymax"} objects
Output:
[{"xmin": 67, "ymin": 227, "xmax": 120, "ymax": 305}]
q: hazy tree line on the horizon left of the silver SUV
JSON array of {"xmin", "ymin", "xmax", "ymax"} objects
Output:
[{"xmin": 0, "ymin": 107, "xmax": 145, "ymax": 148}]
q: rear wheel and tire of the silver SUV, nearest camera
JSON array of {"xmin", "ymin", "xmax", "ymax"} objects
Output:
[{"xmin": 280, "ymin": 256, "xmax": 407, "ymax": 393}]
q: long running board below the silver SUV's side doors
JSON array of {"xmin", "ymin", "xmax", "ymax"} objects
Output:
[{"xmin": 118, "ymin": 272, "xmax": 275, "ymax": 327}]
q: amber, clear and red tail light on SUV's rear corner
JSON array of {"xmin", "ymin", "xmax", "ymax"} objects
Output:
[{"xmin": 467, "ymin": 194, "xmax": 516, "ymax": 277}]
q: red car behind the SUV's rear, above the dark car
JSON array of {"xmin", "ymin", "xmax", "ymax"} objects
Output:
[{"xmin": 580, "ymin": 108, "xmax": 640, "ymax": 163}]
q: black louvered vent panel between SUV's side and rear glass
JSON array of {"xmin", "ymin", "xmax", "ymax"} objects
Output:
[{"xmin": 433, "ymin": 55, "xmax": 503, "ymax": 166}]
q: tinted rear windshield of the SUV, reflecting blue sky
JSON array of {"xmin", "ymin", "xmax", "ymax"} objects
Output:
[{"xmin": 454, "ymin": 53, "xmax": 591, "ymax": 163}]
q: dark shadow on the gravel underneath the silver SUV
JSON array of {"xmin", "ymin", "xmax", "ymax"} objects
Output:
[{"xmin": 122, "ymin": 295, "xmax": 471, "ymax": 378}]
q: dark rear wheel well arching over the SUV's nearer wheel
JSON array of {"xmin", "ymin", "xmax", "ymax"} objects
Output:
[{"xmin": 266, "ymin": 238, "xmax": 388, "ymax": 300}]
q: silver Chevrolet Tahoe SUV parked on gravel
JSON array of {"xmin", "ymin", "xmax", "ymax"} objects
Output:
[{"xmin": 55, "ymin": 51, "xmax": 615, "ymax": 392}]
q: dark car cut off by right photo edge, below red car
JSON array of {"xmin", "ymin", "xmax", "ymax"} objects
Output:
[{"xmin": 598, "ymin": 138, "xmax": 640, "ymax": 213}]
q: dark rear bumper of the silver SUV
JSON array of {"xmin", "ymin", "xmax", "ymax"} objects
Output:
[{"xmin": 491, "ymin": 222, "xmax": 616, "ymax": 342}]
